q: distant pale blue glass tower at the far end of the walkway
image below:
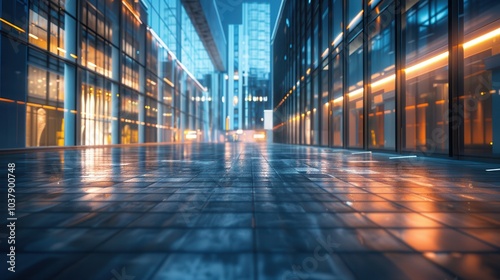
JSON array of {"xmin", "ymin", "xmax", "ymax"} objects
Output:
[{"xmin": 224, "ymin": 2, "xmax": 271, "ymax": 130}]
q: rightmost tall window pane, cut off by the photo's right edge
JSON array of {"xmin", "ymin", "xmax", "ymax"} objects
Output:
[{"xmin": 462, "ymin": 0, "xmax": 500, "ymax": 156}]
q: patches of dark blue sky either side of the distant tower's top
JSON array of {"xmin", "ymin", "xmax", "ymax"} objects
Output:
[{"xmin": 215, "ymin": 0, "xmax": 281, "ymax": 37}]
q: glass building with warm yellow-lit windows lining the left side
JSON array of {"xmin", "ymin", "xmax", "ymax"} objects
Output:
[{"xmin": 0, "ymin": 0, "xmax": 225, "ymax": 148}]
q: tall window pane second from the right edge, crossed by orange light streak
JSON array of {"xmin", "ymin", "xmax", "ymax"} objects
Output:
[{"xmin": 403, "ymin": 0, "xmax": 448, "ymax": 154}]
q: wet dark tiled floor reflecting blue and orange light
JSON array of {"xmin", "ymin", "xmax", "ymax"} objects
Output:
[{"xmin": 0, "ymin": 143, "xmax": 500, "ymax": 280}]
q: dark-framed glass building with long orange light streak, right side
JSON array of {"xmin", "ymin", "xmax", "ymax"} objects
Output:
[{"xmin": 272, "ymin": 0, "xmax": 500, "ymax": 158}]
